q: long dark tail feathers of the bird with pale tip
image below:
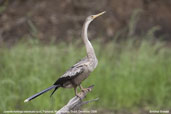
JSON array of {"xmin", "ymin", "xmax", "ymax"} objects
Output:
[{"xmin": 24, "ymin": 85, "xmax": 59, "ymax": 102}]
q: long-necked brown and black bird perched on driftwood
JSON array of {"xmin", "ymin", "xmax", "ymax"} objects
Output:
[{"xmin": 24, "ymin": 11, "xmax": 105, "ymax": 102}]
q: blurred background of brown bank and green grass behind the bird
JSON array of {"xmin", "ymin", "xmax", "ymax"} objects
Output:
[{"xmin": 0, "ymin": 0, "xmax": 171, "ymax": 114}]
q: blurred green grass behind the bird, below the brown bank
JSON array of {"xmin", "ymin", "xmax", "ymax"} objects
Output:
[{"xmin": 0, "ymin": 38, "xmax": 171, "ymax": 111}]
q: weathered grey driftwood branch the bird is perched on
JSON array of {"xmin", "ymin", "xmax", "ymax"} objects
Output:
[{"xmin": 56, "ymin": 85, "xmax": 98, "ymax": 114}]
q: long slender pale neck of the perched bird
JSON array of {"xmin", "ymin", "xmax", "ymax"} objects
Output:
[{"xmin": 82, "ymin": 21, "xmax": 96, "ymax": 59}]
